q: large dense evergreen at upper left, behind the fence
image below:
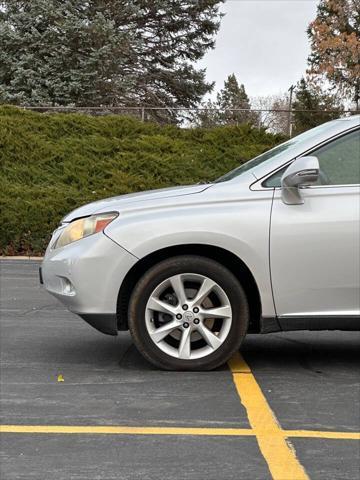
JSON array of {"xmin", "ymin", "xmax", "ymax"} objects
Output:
[{"xmin": 0, "ymin": 0, "xmax": 222, "ymax": 114}]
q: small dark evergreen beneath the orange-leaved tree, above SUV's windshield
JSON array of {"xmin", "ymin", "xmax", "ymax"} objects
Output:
[{"xmin": 293, "ymin": 78, "xmax": 343, "ymax": 135}]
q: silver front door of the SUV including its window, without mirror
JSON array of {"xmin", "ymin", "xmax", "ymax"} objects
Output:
[{"xmin": 270, "ymin": 129, "xmax": 360, "ymax": 328}]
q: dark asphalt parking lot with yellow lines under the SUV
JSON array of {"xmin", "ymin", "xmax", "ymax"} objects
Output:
[{"xmin": 0, "ymin": 260, "xmax": 360, "ymax": 480}]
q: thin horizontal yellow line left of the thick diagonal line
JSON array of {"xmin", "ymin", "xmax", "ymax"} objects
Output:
[{"xmin": 0, "ymin": 425, "xmax": 255, "ymax": 437}]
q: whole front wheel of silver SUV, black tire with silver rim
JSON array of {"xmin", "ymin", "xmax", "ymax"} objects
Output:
[{"xmin": 128, "ymin": 255, "xmax": 249, "ymax": 370}]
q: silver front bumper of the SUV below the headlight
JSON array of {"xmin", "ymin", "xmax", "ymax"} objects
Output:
[{"xmin": 41, "ymin": 233, "xmax": 138, "ymax": 335}]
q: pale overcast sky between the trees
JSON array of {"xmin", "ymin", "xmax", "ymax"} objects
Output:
[{"xmin": 200, "ymin": 0, "xmax": 318, "ymax": 96}]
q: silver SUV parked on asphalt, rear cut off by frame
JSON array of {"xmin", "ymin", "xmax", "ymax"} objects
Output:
[{"xmin": 40, "ymin": 116, "xmax": 360, "ymax": 370}]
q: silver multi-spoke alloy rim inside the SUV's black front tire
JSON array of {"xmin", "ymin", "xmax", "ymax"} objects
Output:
[{"xmin": 145, "ymin": 273, "xmax": 232, "ymax": 360}]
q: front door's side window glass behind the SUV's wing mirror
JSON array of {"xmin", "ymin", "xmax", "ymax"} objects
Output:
[{"xmin": 311, "ymin": 130, "xmax": 360, "ymax": 185}]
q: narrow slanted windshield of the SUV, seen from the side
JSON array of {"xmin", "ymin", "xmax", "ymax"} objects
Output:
[{"xmin": 215, "ymin": 120, "xmax": 337, "ymax": 183}]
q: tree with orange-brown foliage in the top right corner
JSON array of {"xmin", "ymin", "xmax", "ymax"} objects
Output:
[{"xmin": 308, "ymin": 0, "xmax": 360, "ymax": 109}]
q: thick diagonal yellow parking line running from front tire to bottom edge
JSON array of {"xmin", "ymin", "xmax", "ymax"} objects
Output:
[{"xmin": 229, "ymin": 353, "xmax": 309, "ymax": 480}]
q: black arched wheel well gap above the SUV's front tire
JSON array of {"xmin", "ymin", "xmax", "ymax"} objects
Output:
[{"xmin": 117, "ymin": 244, "xmax": 261, "ymax": 333}]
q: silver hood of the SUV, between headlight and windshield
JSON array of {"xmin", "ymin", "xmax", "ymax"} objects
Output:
[{"xmin": 61, "ymin": 184, "xmax": 211, "ymax": 223}]
